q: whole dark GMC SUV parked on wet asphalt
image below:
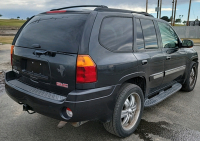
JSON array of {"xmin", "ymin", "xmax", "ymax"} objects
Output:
[{"xmin": 5, "ymin": 5, "xmax": 198, "ymax": 137}]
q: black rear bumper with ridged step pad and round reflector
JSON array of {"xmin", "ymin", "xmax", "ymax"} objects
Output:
[{"xmin": 5, "ymin": 71, "xmax": 119, "ymax": 122}]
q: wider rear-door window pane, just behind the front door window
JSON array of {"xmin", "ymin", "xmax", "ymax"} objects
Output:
[{"xmin": 141, "ymin": 19, "xmax": 158, "ymax": 49}]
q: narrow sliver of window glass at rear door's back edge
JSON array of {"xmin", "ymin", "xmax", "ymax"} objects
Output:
[{"xmin": 136, "ymin": 19, "xmax": 144, "ymax": 50}]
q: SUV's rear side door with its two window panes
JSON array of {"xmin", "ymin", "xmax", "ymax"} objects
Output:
[{"xmin": 135, "ymin": 18, "xmax": 164, "ymax": 94}]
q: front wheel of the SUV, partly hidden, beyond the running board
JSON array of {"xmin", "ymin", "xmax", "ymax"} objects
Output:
[{"xmin": 181, "ymin": 62, "xmax": 198, "ymax": 92}]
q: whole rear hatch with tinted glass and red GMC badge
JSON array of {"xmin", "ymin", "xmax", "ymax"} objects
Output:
[{"xmin": 12, "ymin": 13, "xmax": 88, "ymax": 95}]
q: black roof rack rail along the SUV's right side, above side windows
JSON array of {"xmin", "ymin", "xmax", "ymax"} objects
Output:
[{"xmin": 94, "ymin": 7, "xmax": 154, "ymax": 17}]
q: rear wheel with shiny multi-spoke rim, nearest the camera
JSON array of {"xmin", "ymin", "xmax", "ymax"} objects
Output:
[{"xmin": 104, "ymin": 83, "xmax": 144, "ymax": 137}]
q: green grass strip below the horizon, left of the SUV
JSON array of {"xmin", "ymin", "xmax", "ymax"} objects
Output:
[{"xmin": 0, "ymin": 19, "xmax": 26, "ymax": 28}]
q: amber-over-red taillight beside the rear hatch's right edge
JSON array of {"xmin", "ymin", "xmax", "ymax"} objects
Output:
[{"xmin": 76, "ymin": 55, "xmax": 97, "ymax": 83}]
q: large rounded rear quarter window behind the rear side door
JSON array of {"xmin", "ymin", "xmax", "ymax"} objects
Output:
[{"xmin": 99, "ymin": 17, "xmax": 133, "ymax": 52}]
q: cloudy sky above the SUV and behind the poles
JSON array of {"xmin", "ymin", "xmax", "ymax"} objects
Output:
[{"xmin": 0, "ymin": 0, "xmax": 200, "ymax": 20}]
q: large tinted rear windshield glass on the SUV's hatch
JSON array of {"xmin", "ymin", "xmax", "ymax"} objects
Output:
[{"xmin": 15, "ymin": 14, "xmax": 88, "ymax": 53}]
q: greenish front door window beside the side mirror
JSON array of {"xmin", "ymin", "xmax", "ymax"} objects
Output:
[{"xmin": 158, "ymin": 22, "xmax": 178, "ymax": 48}]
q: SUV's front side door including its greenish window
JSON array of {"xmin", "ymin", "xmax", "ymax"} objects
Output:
[{"xmin": 158, "ymin": 22, "xmax": 186, "ymax": 84}]
